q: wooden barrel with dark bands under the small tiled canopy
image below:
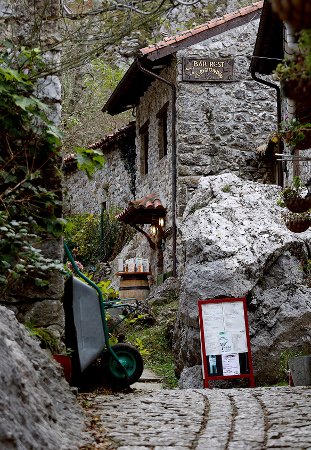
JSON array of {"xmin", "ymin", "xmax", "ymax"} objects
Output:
[{"xmin": 119, "ymin": 272, "xmax": 149, "ymax": 300}]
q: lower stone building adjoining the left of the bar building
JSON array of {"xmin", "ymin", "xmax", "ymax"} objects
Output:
[{"xmin": 63, "ymin": 122, "xmax": 136, "ymax": 216}]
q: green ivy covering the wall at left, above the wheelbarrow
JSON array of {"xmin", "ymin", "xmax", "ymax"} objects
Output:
[{"xmin": 0, "ymin": 42, "xmax": 64, "ymax": 292}]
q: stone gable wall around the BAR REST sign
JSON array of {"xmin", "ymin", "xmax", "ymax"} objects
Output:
[{"xmin": 177, "ymin": 20, "xmax": 277, "ymax": 216}]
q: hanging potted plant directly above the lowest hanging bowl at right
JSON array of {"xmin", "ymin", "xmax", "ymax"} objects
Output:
[{"xmin": 277, "ymin": 176, "xmax": 311, "ymax": 213}]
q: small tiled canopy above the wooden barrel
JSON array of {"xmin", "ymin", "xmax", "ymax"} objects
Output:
[{"xmin": 117, "ymin": 194, "xmax": 166, "ymax": 224}]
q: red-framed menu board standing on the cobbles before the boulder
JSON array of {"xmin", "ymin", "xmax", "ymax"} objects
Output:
[{"xmin": 198, "ymin": 298, "xmax": 255, "ymax": 388}]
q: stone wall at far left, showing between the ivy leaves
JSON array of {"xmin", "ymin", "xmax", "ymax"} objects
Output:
[{"xmin": 0, "ymin": 0, "xmax": 64, "ymax": 335}]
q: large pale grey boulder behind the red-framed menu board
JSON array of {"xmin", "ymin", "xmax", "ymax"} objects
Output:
[{"xmin": 174, "ymin": 173, "xmax": 311, "ymax": 385}]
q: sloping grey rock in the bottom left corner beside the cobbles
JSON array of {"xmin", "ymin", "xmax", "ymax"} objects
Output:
[{"xmin": 0, "ymin": 306, "xmax": 84, "ymax": 450}]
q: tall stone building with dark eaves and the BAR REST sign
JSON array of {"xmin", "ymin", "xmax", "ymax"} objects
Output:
[{"xmin": 67, "ymin": 2, "xmax": 277, "ymax": 280}]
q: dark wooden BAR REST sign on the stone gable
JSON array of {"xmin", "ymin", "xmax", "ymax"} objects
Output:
[{"xmin": 182, "ymin": 58, "xmax": 234, "ymax": 81}]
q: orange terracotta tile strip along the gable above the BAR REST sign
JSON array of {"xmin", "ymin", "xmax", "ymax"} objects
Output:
[{"xmin": 139, "ymin": 1, "xmax": 263, "ymax": 57}]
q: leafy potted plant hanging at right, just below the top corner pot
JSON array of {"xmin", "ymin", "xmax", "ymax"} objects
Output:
[{"xmin": 274, "ymin": 29, "xmax": 311, "ymax": 103}]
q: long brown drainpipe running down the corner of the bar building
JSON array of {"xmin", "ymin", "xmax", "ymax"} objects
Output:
[{"xmin": 137, "ymin": 61, "xmax": 177, "ymax": 277}]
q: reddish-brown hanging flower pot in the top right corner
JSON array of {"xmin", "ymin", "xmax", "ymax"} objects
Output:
[{"xmin": 271, "ymin": 0, "xmax": 311, "ymax": 31}]
